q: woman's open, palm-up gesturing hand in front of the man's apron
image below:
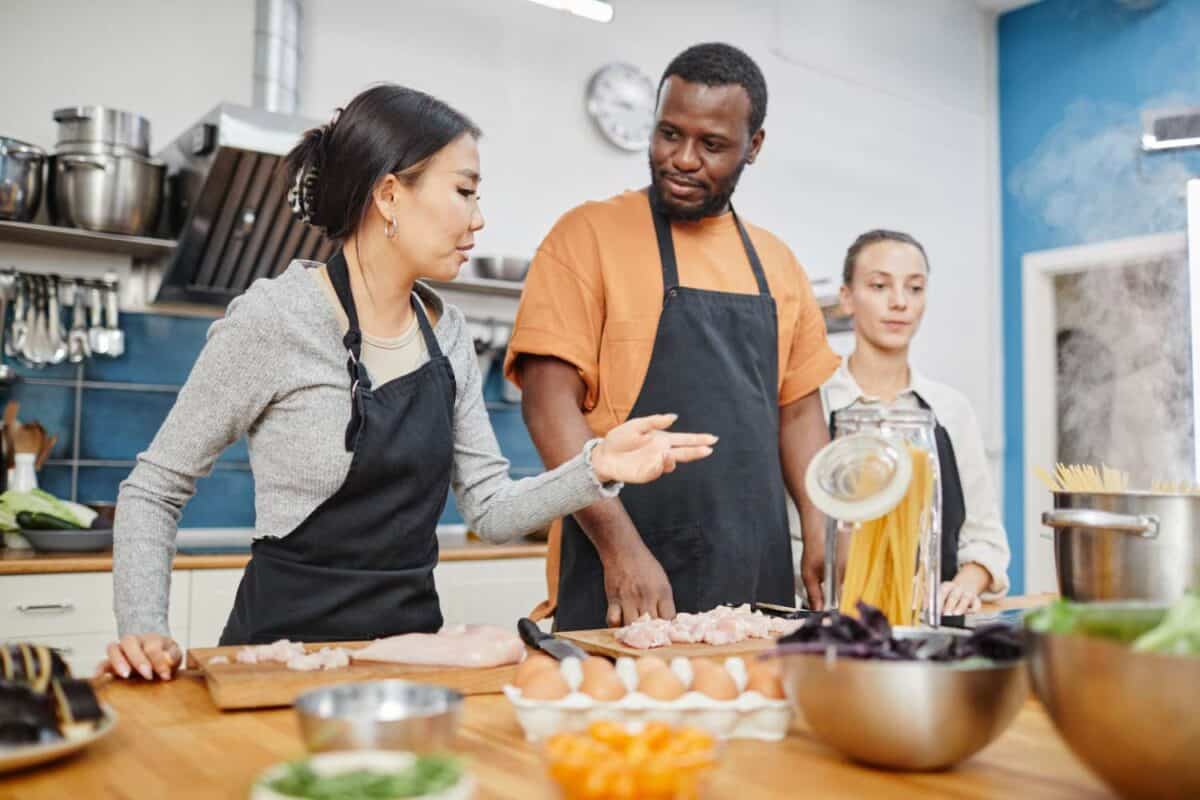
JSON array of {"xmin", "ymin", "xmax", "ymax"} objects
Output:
[{"xmin": 592, "ymin": 414, "xmax": 716, "ymax": 483}]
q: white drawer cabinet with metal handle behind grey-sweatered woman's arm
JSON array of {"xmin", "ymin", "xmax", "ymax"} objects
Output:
[{"xmin": 0, "ymin": 571, "xmax": 190, "ymax": 675}]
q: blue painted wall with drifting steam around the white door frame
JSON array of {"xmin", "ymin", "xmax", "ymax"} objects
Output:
[{"xmin": 998, "ymin": 0, "xmax": 1200, "ymax": 591}]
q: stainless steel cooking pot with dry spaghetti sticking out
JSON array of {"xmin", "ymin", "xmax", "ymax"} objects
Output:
[{"xmin": 1042, "ymin": 492, "xmax": 1200, "ymax": 603}]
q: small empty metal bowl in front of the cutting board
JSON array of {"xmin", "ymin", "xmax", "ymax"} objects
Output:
[{"xmin": 295, "ymin": 680, "xmax": 462, "ymax": 753}]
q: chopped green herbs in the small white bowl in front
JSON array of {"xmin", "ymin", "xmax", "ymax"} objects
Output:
[{"xmin": 268, "ymin": 756, "xmax": 462, "ymax": 800}]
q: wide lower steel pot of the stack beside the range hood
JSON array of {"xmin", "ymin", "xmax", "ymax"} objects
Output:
[{"xmin": 47, "ymin": 154, "xmax": 167, "ymax": 236}]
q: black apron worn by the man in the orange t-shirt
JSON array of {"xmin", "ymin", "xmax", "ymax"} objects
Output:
[{"xmin": 554, "ymin": 194, "xmax": 796, "ymax": 631}]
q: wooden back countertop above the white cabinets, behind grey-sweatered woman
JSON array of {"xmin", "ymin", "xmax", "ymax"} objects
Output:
[{"xmin": 0, "ymin": 535, "xmax": 546, "ymax": 575}]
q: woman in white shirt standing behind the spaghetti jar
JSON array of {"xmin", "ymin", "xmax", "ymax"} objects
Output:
[{"xmin": 821, "ymin": 230, "xmax": 1009, "ymax": 614}]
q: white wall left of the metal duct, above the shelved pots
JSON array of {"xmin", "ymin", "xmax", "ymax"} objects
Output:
[{"xmin": 0, "ymin": 0, "xmax": 254, "ymax": 159}]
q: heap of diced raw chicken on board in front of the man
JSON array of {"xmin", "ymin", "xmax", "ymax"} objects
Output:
[{"xmin": 614, "ymin": 604, "xmax": 800, "ymax": 650}]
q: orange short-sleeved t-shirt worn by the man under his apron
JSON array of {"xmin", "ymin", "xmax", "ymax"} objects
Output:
[{"xmin": 504, "ymin": 191, "xmax": 839, "ymax": 619}]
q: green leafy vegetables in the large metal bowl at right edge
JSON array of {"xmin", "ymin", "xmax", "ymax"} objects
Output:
[{"xmin": 1026, "ymin": 588, "xmax": 1200, "ymax": 656}]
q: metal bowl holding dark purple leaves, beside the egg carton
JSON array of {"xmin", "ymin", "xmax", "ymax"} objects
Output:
[{"xmin": 781, "ymin": 628, "xmax": 1030, "ymax": 770}]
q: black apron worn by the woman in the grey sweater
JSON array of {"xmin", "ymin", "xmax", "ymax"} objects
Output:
[{"xmin": 221, "ymin": 252, "xmax": 456, "ymax": 645}]
